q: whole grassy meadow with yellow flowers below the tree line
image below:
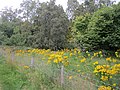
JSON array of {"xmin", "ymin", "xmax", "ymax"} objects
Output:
[{"xmin": 0, "ymin": 47, "xmax": 120, "ymax": 90}]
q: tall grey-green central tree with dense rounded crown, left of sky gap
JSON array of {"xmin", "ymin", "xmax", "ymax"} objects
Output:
[{"xmin": 34, "ymin": 0, "xmax": 68, "ymax": 50}]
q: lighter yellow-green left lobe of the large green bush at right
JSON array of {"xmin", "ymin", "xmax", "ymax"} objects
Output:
[{"xmin": 73, "ymin": 14, "xmax": 93, "ymax": 48}]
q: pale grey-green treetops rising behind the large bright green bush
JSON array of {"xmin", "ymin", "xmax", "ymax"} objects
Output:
[{"xmin": 66, "ymin": 0, "xmax": 115, "ymax": 20}]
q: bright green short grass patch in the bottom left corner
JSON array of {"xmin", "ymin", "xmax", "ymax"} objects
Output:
[{"xmin": 0, "ymin": 57, "xmax": 27, "ymax": 90}]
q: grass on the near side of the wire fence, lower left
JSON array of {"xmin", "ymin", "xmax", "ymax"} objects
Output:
[{"xmin": 0, "ymin": 57, "xmax": 62, "ymax": 90}]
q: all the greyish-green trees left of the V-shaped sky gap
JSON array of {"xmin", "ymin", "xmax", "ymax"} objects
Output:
[{"xmin": 0, "ymin": 0, "xmax": 68, "ymax": 50}]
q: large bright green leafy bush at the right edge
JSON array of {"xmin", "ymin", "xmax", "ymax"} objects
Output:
[{"xmin": 74, "ymin": 4, "xmax": 120, "ymax": 50}]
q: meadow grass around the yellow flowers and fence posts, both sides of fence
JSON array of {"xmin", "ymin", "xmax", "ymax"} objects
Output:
[{"xmin": 0, "ymin": 46, "xmax": 119, "ymax": 90}]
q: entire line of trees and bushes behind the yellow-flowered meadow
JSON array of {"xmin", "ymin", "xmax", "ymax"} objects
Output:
[{"xmin": 0, "ymin": 0, "xmax": 120, "ymax": 50}]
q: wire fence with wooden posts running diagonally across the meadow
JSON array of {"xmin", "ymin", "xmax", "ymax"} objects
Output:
[{"xmin": 0, "ymin": 48, "xmax": 120, "ymax": 90}]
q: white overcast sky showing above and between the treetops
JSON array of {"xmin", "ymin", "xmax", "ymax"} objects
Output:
[{"xmin": 0, "ymin": 0, "xmax": 120, "ymax": 10}]
